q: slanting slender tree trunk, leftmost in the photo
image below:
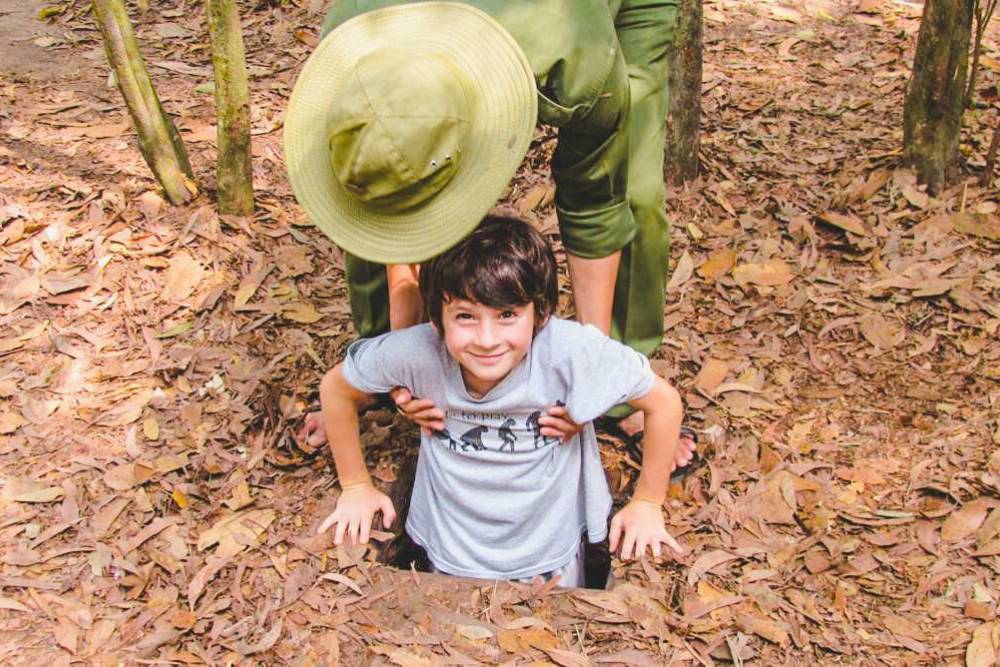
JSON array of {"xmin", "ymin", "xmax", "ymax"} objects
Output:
[{"xmin": 93, "ymin": 0, "xmax": 195, "ymax": 204}]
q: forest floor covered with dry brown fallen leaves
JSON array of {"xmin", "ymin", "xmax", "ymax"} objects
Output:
[{"xmin": 0, "ymin": 0, "xmax": 1000, "ymax": 666}]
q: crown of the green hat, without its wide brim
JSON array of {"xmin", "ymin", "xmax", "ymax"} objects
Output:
[{"xmin": 327, "ymin": 47, "xmax": 472, "ymax": 211}]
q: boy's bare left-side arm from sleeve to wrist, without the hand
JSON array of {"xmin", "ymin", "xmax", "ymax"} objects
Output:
[{"xmin": 319, "ymin": 365, "xmax": 371, "ymax": 487}]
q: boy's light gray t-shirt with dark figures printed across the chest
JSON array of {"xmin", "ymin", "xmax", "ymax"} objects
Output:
[{"xmin": 344, "ymin": 318, "xmax": 654, "ymax": 579}]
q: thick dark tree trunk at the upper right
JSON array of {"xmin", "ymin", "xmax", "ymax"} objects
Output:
[{"xmin": 903, "ymin": 0, "xmax": 975, "ymax": 194}]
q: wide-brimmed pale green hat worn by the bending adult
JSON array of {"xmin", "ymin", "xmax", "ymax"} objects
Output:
[{"xmin": 285, "ymin": 2, "xmax": 538, "ymax": 264}]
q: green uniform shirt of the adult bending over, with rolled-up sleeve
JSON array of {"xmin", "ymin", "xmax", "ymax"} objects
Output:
[{"xmin": 322, "ymin": 0, "xmax": 635, "ymax": 257}]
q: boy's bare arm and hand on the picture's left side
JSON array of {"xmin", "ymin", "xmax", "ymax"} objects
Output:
[{"xmin": 316, "ymin": 364, "xmax": 396, "ymax": 544}]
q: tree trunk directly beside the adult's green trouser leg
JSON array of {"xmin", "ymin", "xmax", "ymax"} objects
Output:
[{"xmin": 664, "ymin": 0, "xmax": 702, "ymax": 183}]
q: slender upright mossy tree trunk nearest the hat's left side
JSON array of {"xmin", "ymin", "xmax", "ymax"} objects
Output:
[{"xmin": 205, "ymin": 0, "xmax": 253, "ymax": 215}]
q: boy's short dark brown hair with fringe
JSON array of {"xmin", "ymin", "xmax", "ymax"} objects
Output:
[{"xmin": 420, "ymin": 215, "xmax": 559, "ymax": 332}]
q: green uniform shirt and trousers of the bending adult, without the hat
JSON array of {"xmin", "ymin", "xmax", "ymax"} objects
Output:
[{"xmin": 323, "ymin": 0, "xmax": 676, "ymax": 355}]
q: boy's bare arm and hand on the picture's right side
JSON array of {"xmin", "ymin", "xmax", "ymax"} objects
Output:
[{"xmin": 610, "ymin": 377, "xmax": 683, "ymax": 559}]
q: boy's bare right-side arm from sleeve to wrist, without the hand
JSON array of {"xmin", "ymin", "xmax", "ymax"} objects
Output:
[{"xmin": 632, "ymin": 379, "xmax": 683, "ymax": 505}]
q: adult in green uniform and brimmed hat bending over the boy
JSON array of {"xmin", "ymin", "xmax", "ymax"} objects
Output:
[{"xmin": 285, "ymin": 0, "xmax": 693, "ymax": 465}]
